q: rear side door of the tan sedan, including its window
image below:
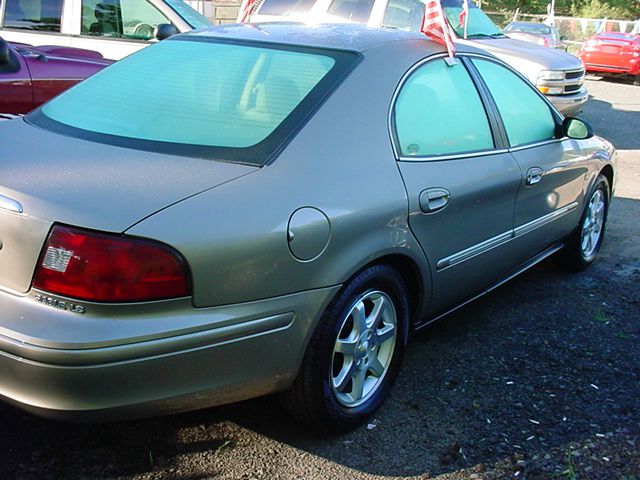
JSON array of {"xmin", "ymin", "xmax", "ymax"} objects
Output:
[{"xmin": 391, "ymin": 57, "xmax": 521, "ymax": 313}]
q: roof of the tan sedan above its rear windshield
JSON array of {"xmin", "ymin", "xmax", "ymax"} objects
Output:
[{"xmin": 180, "ymin": 22, "xmax": 458, "ymax": 52}]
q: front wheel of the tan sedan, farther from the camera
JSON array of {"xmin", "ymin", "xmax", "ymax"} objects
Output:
[{"xmin": 557, "ymin": 175, "xmax": 611, "ymax": 271}]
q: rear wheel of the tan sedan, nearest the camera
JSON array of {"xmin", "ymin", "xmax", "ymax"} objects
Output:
[{"xmin": 283, "ymin": 265, "xmax": 409, "ymax": 432}]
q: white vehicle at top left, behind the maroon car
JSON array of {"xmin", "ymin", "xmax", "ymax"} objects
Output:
[{"xmin": 0, "ymin": 0, "xmax": 211, "ymax": 60}]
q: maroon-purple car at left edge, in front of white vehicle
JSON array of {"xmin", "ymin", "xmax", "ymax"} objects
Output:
[{"xmin": 0, "ymin": 38, "xmax": 113, "ymax": 119}]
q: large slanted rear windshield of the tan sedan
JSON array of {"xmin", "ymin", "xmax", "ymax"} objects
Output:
[{"xmin": 27, "ymin": 37, "xmax": 358, "ymax": 165}]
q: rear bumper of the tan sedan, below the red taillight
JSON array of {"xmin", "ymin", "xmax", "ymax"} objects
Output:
[{"xmin": 0, "ymin": 287, "xmax": 339, "ymax": 421}]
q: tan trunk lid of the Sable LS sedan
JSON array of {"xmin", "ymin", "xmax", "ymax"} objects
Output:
[{"xmin": 0, "ymin": 119, "xmax": 258, "ymax": 293}]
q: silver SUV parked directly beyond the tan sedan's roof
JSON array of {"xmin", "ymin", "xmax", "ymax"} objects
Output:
[{"xmin": 250, "ymin": 0, "xmax": 588, "ymax": 115}]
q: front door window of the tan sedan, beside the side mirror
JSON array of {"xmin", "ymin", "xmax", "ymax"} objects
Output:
[{"xmin": 473, "ymin": 59, "xmax": 556, "ymax": 147}]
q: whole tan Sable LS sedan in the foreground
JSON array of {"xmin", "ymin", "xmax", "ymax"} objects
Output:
[{"xmin": 0, "ymin": 23, "xmax": 615, "ymax": 431}]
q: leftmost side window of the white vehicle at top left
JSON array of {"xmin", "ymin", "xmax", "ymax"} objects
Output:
[{"xmin": 2, "ymin": 0, "xmax": 62, "ymax": 32}]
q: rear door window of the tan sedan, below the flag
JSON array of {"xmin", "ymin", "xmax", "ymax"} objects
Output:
[{"xmin": 394, "ymin": 59, "xmax": 494, "ymax": 157}]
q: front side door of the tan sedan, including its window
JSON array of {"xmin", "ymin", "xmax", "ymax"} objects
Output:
[{"xmin": 473, "ymin": 58, "xmax": 589, "ymax": 261}]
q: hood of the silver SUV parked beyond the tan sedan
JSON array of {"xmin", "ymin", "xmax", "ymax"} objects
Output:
[{"xmin": 458, "ymin": 38, "xmax": 582, "ymax": 70}]
